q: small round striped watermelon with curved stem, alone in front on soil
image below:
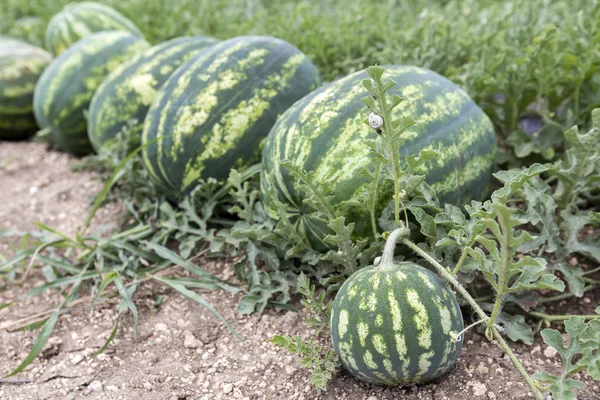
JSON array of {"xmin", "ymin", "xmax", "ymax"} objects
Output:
[{"xmin": 330, "ymin": 228, "xmax": 464, "ymax": 386}]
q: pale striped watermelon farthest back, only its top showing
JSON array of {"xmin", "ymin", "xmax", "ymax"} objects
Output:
[{"xmin": 46, "ymin": 1, "xmax": 143, "ymax": 55}]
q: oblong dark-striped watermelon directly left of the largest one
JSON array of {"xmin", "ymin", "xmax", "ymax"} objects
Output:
[{"xmin": 142, "ymin": 36, "xmax": 319, "ymax": 195}]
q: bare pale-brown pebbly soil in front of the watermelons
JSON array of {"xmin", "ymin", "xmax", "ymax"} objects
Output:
[{"xmin": 0, "ymin": 143, "xmax": 600, "ymax": 400}]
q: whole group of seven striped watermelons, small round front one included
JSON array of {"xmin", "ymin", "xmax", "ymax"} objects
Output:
[{"xmin": 0, "ymin": 3, "xmax": 496, "ymax": 384}]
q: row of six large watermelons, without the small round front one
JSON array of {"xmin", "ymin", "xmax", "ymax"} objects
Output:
[{"xmin": 0, "ymin": 3, "xmax": 496, "ymax": 249}]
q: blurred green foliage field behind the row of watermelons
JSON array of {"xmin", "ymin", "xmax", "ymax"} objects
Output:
[{"xmin": 0, "ymin": 0, "xmax": 600, "ymax": 162}]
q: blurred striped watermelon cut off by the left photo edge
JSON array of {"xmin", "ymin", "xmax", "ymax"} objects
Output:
[{"xmin": 0, "ymin": 38, "xmax": 52, "ymax": 139}]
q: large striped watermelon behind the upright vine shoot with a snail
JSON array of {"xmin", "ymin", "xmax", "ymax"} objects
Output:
[{"xmin": 261, "ymin": 66, "xmax": 496, "ymax": 249}]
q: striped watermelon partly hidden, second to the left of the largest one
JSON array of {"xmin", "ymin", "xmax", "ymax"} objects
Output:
[{"xmin": 88, "ymin": 36, "xmax": 217, "ymax": 151}]
